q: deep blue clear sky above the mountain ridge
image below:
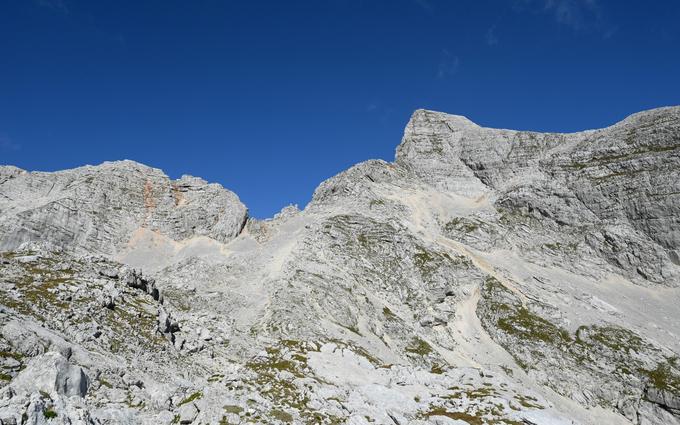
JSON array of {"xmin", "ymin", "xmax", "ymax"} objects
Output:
[{"xmin": 0, "ymin": 0, "xmax": 680, "ymax": 218}]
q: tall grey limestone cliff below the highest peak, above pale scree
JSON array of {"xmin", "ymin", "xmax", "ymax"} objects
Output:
[{"xmin": 396, "ymin": 108, "xmax": 680, "ymax": 284}]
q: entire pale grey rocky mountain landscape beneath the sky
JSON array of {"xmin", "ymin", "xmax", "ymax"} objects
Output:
[{"xmin": 0, "ymin": 107, "xmax": 680, "ymax": 425}]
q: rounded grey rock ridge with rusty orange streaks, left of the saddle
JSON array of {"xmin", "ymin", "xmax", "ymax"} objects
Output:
[{"xmin": 0, "ymin": 161, "xmax": 247, "ymax": 255}]
